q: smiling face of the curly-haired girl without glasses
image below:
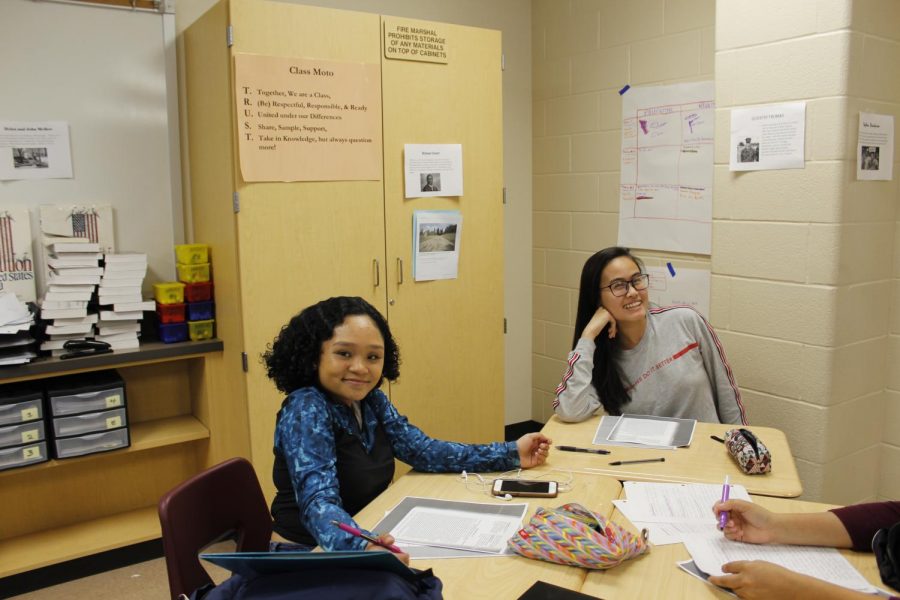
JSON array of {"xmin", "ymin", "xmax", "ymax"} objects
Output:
[{"xmin": 319, "ymin": 315, "xmax": 384, "ymax": 405}]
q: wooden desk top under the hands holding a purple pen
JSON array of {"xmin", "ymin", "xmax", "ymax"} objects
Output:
[{"xmin": 581, "ymin": 496, "xmax": 885, "ymax": 600}]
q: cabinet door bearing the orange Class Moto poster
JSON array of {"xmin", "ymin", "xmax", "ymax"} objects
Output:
[{"xmin": 231, "ymin": 1, "xmax": 385, "ymax": 492}]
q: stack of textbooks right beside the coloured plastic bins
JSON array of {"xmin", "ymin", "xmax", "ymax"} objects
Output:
[{"xmin": 96, "ymin": 253, "xmax": 156, "ymax": 350}]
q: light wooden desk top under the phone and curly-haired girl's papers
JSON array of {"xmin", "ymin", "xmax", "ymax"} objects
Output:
[{"xmin": 354, "ymin": 468, "xmax": 622, "ymax": 600}]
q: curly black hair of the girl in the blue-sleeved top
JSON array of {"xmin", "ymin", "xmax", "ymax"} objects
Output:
[{"xmin": 262, "ymin": 296, "xmax": 400, "ymax": 394}]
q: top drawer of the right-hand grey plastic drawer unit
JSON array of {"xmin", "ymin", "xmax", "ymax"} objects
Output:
[{"xmin": 47, "ymin": 371, "xmax": 125, "ymax": 417}]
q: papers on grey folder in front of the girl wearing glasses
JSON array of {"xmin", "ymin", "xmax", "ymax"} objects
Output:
[{"xmin": 594, "ymin": 415, "xmax": 697, "ymax": 450}]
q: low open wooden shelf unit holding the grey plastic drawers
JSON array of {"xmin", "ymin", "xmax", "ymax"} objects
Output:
[{"xmin": 0, "ymin": 340, "xmax": 232, "ymax": 577}]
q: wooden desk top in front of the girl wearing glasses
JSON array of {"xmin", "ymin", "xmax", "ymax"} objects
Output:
[{"xmin": 541, "ymin": 415, "xmax": 803, "ymax": 498}]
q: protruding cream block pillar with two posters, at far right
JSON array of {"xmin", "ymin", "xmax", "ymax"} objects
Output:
[{"xmin": 712, "ymin": 0, "xmax": 900, "ymax": 503}]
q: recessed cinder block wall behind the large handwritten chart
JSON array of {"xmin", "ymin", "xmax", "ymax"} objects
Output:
[{"xmin": 532, "ymin": 0, "xmax": 712, "ymax": 422}]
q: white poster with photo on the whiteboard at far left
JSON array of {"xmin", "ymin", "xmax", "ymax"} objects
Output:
[{"xmin": 0, "ymin": 121, "xmax": 72, "ymax": 181}]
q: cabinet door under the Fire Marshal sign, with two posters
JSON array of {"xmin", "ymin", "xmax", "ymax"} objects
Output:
[{"xmin": 382, "ymin": 18, "xmax": 504, "ymax": 442}]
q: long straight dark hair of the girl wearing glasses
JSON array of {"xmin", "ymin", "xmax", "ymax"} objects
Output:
[{"xmin": 572, "ymin": 246, "xmax": 644, "ymax": 415}]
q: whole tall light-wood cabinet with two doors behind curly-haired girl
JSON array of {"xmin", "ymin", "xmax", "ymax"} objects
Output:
[{"xmin": 182, "ymin": 0, "xmax": 503, "ymax": 496}]
